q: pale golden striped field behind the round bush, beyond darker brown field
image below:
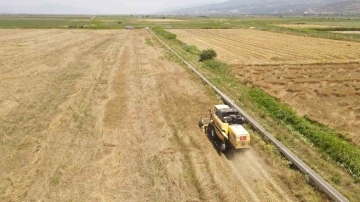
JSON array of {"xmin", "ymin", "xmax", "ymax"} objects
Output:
[{"xmin": 169, "ymin": 29, "xmax": 360, "ymax": 65}]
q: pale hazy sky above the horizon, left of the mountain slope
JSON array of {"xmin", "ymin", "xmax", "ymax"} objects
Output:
[{"xmin": 0, "ymin": 0, "xmax": 224, "ymax": 14}]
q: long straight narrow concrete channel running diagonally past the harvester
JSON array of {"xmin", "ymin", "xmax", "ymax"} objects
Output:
[{"xmin": 147, "ymin": 28, "xmax": 348, "ymax": 202}]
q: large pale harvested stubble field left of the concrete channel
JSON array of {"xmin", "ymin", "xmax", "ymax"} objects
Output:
[{"xmin": 0, "ymin": 30, "xmax": 319, "ymax": 201}]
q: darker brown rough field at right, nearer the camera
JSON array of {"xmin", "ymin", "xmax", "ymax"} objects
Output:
[{"xmin": 233, "ymin": 64, "xmax": 360, "ymax": 145}]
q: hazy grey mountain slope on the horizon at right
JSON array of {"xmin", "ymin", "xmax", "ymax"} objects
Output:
[{"xmin": 167, "ymin": 0, "xmax": 360, "ymax": 15}]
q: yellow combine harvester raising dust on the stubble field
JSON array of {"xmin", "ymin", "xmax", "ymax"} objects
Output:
[{"xmin": 199, "ymin": 105, "xmax": 250, "ymax": 152}]
